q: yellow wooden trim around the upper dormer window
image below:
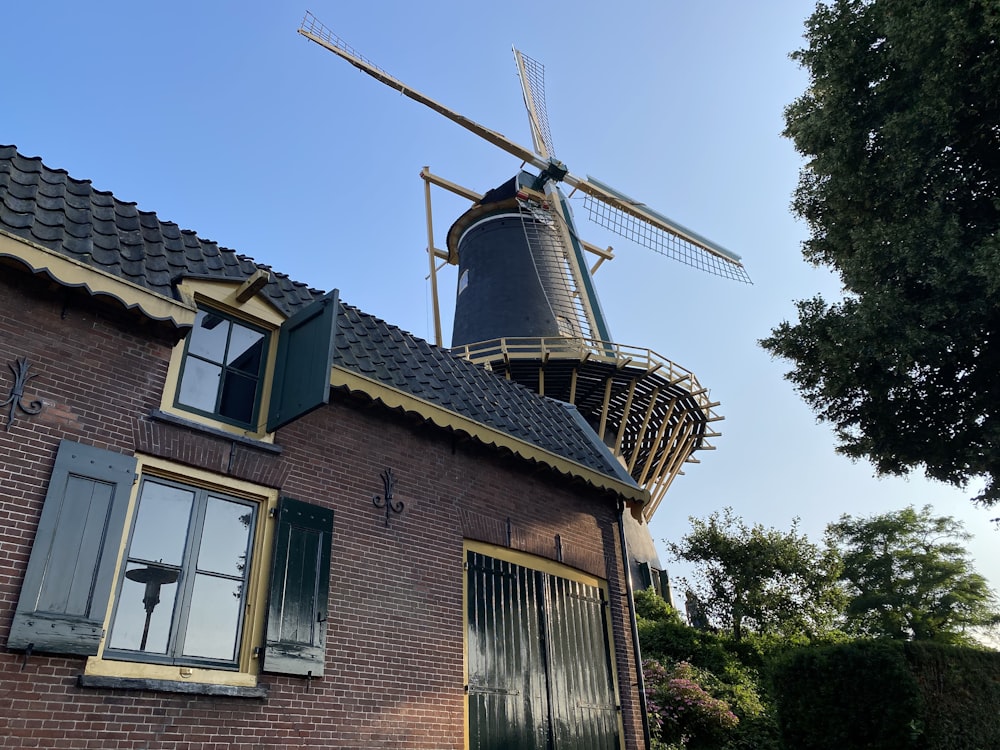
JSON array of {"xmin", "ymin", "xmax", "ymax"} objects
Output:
[{"xmin": 160, "ymin": 284, "xmax": 285, "ymax": 443}]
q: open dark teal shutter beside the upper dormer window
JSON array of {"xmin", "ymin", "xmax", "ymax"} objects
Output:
[{"xmin": 267, "ymin": 289, "xmax": 340, "ymax": 432}]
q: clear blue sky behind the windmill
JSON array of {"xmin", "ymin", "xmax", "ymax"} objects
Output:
[{"xmin": 9, "ymin": 0, "xmax": 1000, "ymax": 604}]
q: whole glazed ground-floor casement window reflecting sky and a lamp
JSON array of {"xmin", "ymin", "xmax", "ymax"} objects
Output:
[{"xmin": 108, "ymin": 478, "xmax": 257, "ymax": 666}]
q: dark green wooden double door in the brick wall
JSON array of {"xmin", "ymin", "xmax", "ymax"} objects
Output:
[{"xmin": 467, "ymin": 551, "xmax": 619, "ymax": 750}]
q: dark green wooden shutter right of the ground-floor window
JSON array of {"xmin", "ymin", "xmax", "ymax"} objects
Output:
[{"xmin": 264, "ymin": 497, "xmax": 333, "ymax": 677}]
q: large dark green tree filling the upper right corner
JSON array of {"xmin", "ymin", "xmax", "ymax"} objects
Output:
[{"xmin": 760, "ymin": 0, "xmax": 1000, "ymax": 504}]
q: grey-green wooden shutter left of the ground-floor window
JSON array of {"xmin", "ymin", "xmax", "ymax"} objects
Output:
[{"xmin": 7, "ymin": 440, "xmax": 136, "ymax": 656}]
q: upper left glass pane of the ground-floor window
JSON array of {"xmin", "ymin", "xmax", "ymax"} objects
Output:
[{"xmin": 128, "ymin": 479, "xmax": 194, "ymax": 565}]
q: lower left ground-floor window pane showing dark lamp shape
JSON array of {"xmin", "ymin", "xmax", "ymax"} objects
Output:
[{"xmin": 111, "ymin": 563, "xmax": 178, "ymax": 654}]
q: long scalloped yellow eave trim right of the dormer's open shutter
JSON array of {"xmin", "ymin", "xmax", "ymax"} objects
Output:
[{"xmin": 330, "ymin": 365, "xmax": 649, "ymax": 503}]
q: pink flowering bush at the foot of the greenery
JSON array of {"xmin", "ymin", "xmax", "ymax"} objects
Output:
[{"xmin": 643, "ymin": 659, "xmax": 740, "ymax": 749}]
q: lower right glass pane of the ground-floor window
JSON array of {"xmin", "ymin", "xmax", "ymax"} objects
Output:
[{"xmin": 184, "ymin": 573, "xmax": 243, "ymax": 661}]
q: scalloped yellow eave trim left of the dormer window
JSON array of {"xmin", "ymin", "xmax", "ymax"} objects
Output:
[{"xmin": 0, "ymin": 229, "xmax": 196, "ymax": 328}]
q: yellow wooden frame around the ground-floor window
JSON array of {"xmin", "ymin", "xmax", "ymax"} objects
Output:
[{"xmin": 84, "ymin": 454, "xmax": 278, "ymax": 687}]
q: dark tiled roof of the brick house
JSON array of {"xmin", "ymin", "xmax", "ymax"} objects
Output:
[{"xmin": 0, "ymin": 146, "xmax": 632, "ymax": 484}]
